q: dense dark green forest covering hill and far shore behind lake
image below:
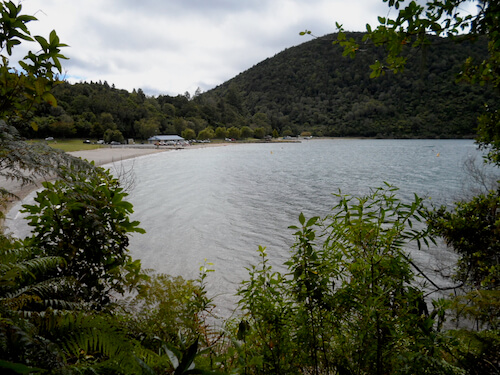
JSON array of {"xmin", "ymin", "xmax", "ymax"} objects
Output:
[{"xmin": 24, "ymin": 33, "xmax": 498, "ymax": 141}]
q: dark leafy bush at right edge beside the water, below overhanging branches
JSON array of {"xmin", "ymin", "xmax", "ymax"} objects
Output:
[{"xmin": 429, "ymin": 190, "xmax": 500, "ymax": 329}]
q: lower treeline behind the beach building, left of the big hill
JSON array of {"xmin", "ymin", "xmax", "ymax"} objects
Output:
[{"xmin": 23, "ymin": 82, "xmax": 270, "ymax": 141}]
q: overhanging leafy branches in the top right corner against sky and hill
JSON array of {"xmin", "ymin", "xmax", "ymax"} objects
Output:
[{"xmin": 332, "ymin": 0, "xmax": 500, "ymax": 165}]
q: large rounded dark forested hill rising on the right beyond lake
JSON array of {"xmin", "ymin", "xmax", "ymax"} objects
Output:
[{"xmin": 199, "ymin": 33, "xmax": 498, "ymax": 137}]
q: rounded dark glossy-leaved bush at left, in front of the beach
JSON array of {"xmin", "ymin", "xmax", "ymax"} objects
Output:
[{"xmin": 23, "ymin": 167, "xmax": 144, "ymax": 308}]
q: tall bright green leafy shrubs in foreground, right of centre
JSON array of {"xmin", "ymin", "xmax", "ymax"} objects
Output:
[{"xmin": 234, "ymin": 187, "xmax": 461, "ymax": 374}]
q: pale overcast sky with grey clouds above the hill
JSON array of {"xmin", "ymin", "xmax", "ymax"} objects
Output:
[{"xmin": 12, "ymin": 0, "xmax": 468, "ymax": 96}]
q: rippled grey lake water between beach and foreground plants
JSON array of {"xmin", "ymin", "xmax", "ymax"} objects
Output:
[{"xmin": 3, "ymin": 139, "xmax": 496, "ymax": 315}]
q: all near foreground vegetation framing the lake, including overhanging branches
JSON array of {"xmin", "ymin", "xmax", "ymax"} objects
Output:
[{"xmin": 0, "ymin": 0, "xmax": 500, "ymax": 374}]
